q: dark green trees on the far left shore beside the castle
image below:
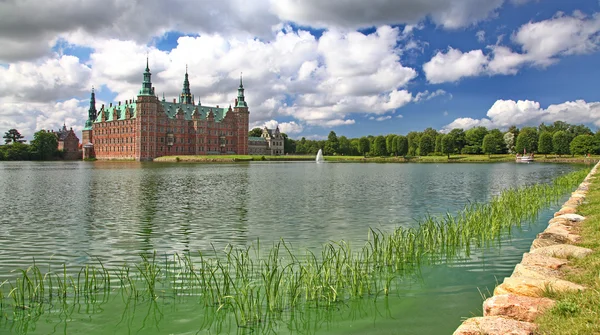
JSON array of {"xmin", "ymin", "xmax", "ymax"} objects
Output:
[{"xmin": 0, "ymin": 129, "xmax": 63, "ymax": 161}]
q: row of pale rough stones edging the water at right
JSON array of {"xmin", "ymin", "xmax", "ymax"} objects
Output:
[{"xmin": 454, "ymin": 163, "xmax": 600, "ymax": 335}]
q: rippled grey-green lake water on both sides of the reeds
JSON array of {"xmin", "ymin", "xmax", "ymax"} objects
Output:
[{"xmin": 0, "ymin": 162, "xmax": 578, "ymax": 334}]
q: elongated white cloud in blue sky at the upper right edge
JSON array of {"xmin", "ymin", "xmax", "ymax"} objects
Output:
[{"xmin": 423, "ymin": 12, "xmax": 600, "ymax": 84}]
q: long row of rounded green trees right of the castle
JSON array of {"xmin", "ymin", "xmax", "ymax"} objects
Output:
[{"xmin": 251, "ymin": 121, "xmax": 600, "ymax": 158}]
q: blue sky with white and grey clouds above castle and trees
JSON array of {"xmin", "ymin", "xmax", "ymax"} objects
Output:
[{"xmin": 0, "ymin": 0, "xmax": 600, "ymax": 139}]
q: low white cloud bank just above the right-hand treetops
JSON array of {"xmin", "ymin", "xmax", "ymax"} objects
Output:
[{"xmin": 443, "ymin": 100, "xmax": 600, "ymax": 131}]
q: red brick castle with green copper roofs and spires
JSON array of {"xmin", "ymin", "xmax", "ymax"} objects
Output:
[{"xmin": 82, "ymin": 61, "xmax": 249, "ymax": 161}]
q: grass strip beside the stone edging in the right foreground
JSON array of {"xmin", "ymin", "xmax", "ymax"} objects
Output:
[{"xmin": 536, "ymin": 176, "xmax": 600, "ymax": 335}]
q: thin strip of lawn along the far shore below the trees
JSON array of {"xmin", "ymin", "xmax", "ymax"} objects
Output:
[{"xmin": 154, "ymin": 155, "xmax": 600, "ymax": 163}]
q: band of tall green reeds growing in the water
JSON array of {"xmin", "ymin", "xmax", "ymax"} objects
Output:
[{"xmin": 0, "ymin": 169, "xmax": 589, "ymax": 327}]
